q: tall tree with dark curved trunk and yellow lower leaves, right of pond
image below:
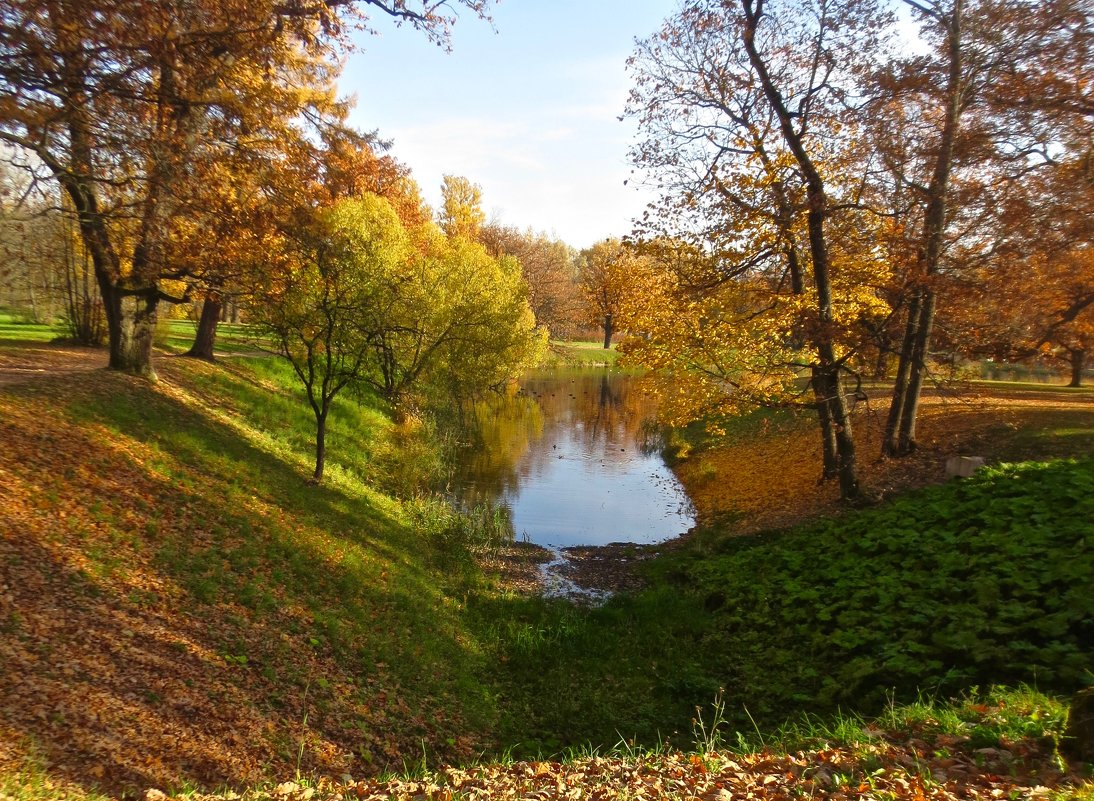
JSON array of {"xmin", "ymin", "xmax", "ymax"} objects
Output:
[{"xmin": 630, "ymin": 0, "xmax": 883, "ymax": 499}]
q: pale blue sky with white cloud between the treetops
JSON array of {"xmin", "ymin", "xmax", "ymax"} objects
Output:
[{"xmin": 339, "ymin": 0, "xmax": 676, "ymax": 248}]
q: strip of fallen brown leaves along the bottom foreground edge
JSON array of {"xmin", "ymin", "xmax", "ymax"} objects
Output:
[{"xmin": 147, "ymin": 730, "xmax": 1082, "ymax": 801}]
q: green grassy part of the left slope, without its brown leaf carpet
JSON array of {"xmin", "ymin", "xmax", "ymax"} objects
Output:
[{"xmin": 0, "ymin": 358, "xmax": 516, "ymax": 798}]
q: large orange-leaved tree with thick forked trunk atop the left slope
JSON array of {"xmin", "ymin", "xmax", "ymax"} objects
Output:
[{"xmin": 0, "ymin": 0, "xmax": 494, "ymax": 375}]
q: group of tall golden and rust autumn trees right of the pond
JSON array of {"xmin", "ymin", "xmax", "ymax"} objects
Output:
[{"xmin": 628, "ymin": 0, "xmax": 1091, "ymax": 490}]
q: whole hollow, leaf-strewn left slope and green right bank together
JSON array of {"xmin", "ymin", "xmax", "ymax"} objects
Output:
[{"xmin": 0, "ymin": 334, "xmax": 1094, "ymax": 801}]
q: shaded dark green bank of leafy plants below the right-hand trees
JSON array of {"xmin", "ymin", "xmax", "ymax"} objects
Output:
[{"xmin": 480, "ymin": 458, "xmax": 1094, "ymax": 753}]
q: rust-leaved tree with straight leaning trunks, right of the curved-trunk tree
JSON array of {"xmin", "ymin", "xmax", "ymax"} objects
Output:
[{"xmin": 873, "ymin": 0, "xmax": 1092, "ymax": 456}]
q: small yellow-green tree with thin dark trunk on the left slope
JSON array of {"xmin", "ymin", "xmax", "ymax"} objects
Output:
[{"xmin": 252, "ymin": 193, "xmax": 544, "ymax": 481}]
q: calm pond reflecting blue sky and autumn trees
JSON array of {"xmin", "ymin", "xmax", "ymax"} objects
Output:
[{"xmin": 449, "ymin": 368, "xmax": 695, "ymax": 550}]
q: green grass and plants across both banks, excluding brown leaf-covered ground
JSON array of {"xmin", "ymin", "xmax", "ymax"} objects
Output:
[{"xmin": 0, "ymin": 324, "xmax": 1094, "ymax": 801}]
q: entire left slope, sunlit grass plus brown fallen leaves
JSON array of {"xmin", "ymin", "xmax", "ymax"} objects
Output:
[{"xmin": 0, "ymin": 359, "xmax": 493, "ymax": 792}]
